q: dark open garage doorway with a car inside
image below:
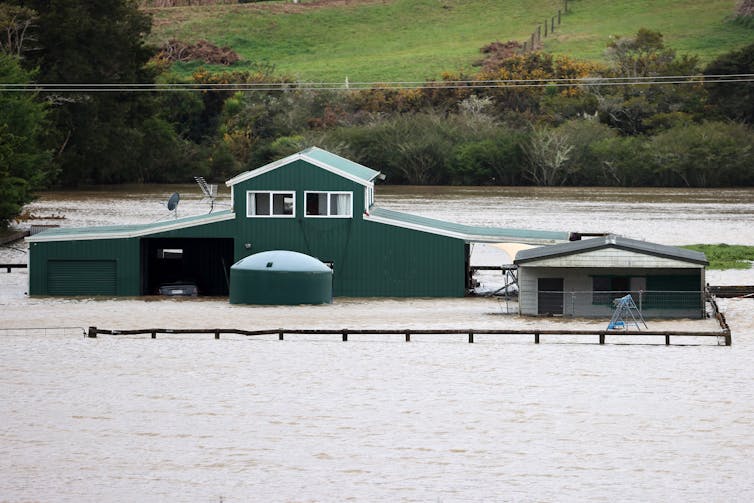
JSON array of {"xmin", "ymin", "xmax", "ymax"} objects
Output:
[{"xmin": 141, "ymin": 238, "xmax": 233, "ymax": 296}]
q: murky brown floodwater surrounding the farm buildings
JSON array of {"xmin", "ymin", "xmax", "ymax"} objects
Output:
[{"xmin": 0, "ymin": 186, "xmax": 754, "ymax": 502}]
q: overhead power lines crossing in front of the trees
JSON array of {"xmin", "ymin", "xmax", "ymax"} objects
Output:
[{"xmin": 0, "ymin": 73, "xmax": 754, "ymax": 93}]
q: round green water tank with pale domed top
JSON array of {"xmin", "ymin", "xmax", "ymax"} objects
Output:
[{"xmin": 230, "ymin": 250, "xmax": 332, "ymax": 305}]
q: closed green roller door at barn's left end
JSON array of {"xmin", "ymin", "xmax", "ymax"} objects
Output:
[{"xmin": 47, "ymin": 260, "xmax": 117, "ymax": 295}]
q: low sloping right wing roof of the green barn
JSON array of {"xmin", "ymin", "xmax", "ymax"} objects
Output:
[{"xmin": 364, "ymin": 206, "xmax": 569, "ymax": 245}]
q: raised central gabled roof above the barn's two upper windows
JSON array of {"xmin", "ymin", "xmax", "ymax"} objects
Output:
[{"xmin": 225, "ymin": 147, "xmax": 380, "ymax": 191}]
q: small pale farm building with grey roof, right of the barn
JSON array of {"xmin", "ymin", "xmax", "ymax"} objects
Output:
[{"xmin": 514, "ymin": 235, "xmax": 708, "ymax": 318}]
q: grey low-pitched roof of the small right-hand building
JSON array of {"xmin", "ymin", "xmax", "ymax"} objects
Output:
[{"xmin": 513, "ymin": 234, "xmax": 709, "ymax": 265}]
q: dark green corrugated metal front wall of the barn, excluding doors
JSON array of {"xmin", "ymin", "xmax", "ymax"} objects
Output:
[{"xmin": 30, "ymin": 161, "xmax": 466, "ymax": 297}]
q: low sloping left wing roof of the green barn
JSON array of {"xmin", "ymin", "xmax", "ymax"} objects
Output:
[{"xmin": 26, "ymin": 210, "xmax": 236, "ymax": 243}]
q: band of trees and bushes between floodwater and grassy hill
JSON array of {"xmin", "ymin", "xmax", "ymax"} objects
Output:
[{"xmin": 0, "ymin": 0, "xmax": 754, "ymax": 225}]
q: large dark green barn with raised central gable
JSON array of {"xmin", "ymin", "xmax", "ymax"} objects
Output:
[{"xmin": 28, "ymin": 147, "xmax": 569, "ymax": 297}]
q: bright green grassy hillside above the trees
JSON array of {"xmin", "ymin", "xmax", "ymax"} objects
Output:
[{"xmin": 151, "ymin": 0, "xmax": 754, "ymax": 82}]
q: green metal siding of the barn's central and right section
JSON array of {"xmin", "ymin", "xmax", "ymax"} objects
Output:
[{"xmin": 233, "ymin": 161, "xmax": 466, "ymax": 297}]
